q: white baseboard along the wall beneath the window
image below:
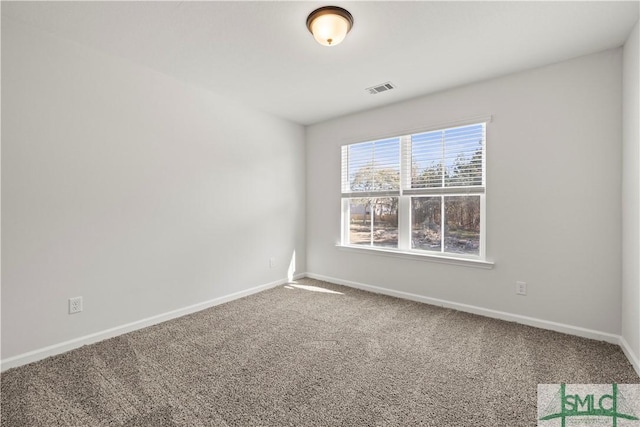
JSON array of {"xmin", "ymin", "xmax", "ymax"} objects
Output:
[{"xmin": 307, "ymin": 273, "xmax": 620, "ymax": 348}]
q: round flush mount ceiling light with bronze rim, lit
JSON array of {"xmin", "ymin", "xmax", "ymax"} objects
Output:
[{"xmin": 307, "ymin": 6, "xmax": 353, "ymax": 46}]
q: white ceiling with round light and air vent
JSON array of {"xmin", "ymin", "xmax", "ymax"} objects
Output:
[{"xmin": 2, "ymin": 1, "xmax": 638, "ymax": 125}]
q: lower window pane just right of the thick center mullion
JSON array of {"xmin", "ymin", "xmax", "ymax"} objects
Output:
[{"xmin": 411, "ymin": 196, "xmax": 442, "ymax": 252}]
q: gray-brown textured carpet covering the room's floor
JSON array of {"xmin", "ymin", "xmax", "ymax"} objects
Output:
[{"xmin": 1, "ymin": 279, "xmax": 640, "ymax": 427}]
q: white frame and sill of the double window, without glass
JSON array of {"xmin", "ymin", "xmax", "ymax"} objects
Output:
[{"xmin": 337, "ymin": 116, "xmax": 494, "ymax": 268}]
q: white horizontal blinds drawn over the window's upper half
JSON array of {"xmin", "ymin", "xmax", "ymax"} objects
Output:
[{"xmin": 342, "ymin": 123, "xmax": 486, "ymax": 197}]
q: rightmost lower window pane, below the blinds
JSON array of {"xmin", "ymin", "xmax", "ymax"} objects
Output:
[{"xmin": 444, "ymin": 196, "xmax": 480, "ymax": 255}]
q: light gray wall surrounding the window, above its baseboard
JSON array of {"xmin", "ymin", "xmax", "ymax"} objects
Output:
[{"xmin": 307, "ymin": 49, "xmax": 622, "ymax": 334}]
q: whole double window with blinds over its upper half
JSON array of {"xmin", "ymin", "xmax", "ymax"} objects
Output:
[{"xmin": 342, "ymin": 122, "xmax": 486, "ymax": 259}]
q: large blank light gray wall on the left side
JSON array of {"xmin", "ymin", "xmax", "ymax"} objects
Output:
[{"xmin": 2, "ymin": 17, "xmax": 305, "ymax": 360}]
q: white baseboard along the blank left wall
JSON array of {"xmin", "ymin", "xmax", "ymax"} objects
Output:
[{"xmin": 0, "ymin": 274, "xmax": 305, "ymax": 372}]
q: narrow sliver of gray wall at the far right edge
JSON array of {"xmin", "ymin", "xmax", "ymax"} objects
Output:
[{"xmin": 622, "ymin": 20, "xmax": 640, "ymax": 369}]
